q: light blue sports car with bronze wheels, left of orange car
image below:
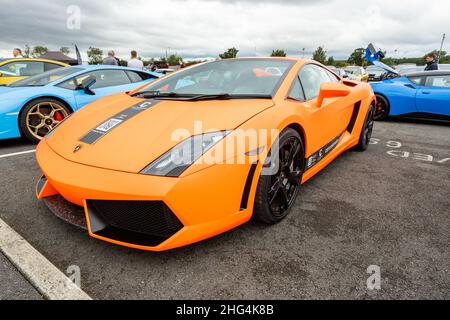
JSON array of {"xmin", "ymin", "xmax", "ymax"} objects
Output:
[{"xmin": 0, "ymin": 65, "xmax": 161, "ymax": 142}]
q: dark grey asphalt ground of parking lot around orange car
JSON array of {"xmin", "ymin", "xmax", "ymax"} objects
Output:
[{"xmin": 0, "ymin": 120, "xmax": 450, "ymax": 299}]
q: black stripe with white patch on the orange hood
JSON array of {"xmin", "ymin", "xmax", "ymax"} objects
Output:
[{"xmin": 80, "ymin": 100, "xmax": 161, "ymax": 144}]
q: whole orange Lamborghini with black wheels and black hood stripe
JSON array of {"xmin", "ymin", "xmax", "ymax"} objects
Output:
[{"xmin": 36, "ymin": 58, "xmax": 375, "ymax": 251}]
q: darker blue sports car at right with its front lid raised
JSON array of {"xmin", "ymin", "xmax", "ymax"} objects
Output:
[{"xmin": 366, "ymin": 46, "xmax": 450, "ymax": 120}]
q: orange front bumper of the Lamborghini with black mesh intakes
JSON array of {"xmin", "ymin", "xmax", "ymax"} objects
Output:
[{"xmin": 36, "ymin": 140, "xmax": 259, "ymax": 251}]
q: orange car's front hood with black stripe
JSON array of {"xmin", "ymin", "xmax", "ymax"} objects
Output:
[{"xmin": 46, "ymin": 93, "xmax": 274, "ymax": 173}]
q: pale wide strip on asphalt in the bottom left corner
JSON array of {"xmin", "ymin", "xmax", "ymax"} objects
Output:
[{"xmin": 0, "ymin": 219, "xmax": 92, "ymax": 300}]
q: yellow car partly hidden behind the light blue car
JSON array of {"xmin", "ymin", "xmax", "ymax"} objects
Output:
[{"xmin": 0, "ymin": 58, "xmax": 69, "ymax": 85}]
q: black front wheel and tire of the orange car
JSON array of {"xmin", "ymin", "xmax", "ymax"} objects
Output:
[{"xmin": 253, "ymin": 128, "xmax": 305, "ymax": 224}]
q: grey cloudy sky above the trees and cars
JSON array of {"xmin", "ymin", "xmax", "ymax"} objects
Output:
[{"xmin": 0, "ymin": 0, "xmax": 450, "ymax": 58}]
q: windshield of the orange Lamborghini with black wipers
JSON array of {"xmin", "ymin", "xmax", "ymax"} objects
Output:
[{"xmin": 138, "ymin": 59, "xmax": 293, "ymax": 97}]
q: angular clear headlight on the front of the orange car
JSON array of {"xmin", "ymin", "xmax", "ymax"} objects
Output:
[{"xmin": 140, "ymin": 131, "xmax": 231, "ymax": 177}]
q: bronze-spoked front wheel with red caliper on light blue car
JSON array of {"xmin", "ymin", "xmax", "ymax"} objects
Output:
[{"xmin": 19, "ymin": 98, "xmax": 70, "ymax": 142}]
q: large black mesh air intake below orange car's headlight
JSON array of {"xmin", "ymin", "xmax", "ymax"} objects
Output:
[{"xmin": 89, "ymin": 201, "xmax": 183, "ymax": 240}]
